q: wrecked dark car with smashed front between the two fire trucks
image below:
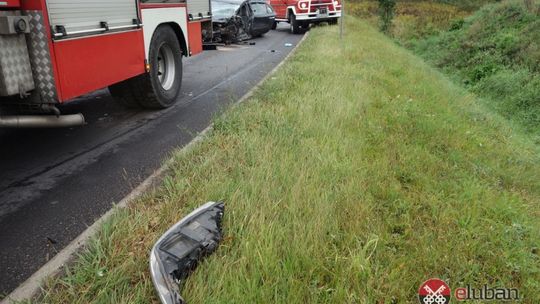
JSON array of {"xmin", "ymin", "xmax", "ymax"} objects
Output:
[{"xmin": 207, "ymin": 0, "xmax": 276, "ymax": 44}]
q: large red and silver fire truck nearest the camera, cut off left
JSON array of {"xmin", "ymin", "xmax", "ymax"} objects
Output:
[{"xmin": 0, "ymin": 0, "xmax": 211, "ymax": 127}]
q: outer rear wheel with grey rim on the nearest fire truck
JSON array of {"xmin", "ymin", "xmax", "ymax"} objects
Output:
[{"xmin": 139, "ymin": 26, "xmax": 182, "ymax": 109}]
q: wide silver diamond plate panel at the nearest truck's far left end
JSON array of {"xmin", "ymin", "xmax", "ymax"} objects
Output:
[{"xmin": 0, "ymin": 11, "xmax": 34, "ymax": 96}]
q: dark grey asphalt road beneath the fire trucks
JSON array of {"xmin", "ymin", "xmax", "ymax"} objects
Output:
[{"xmin": 0, "ymin": 26, "xmax": 301, "ymax": 298}]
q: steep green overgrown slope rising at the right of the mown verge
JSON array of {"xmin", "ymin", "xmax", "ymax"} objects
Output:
[{"xmin": 412, "ymin": 0, "xmax": 540, "ymax": 135}]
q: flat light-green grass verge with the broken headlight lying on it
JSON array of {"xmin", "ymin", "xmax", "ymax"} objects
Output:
[{"xmin": 41, "ymin": 18, "xmax": 540, "ymax": 303}]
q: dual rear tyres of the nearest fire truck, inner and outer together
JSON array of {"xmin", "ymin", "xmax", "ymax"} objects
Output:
[{"xmin": 109, "ymin": 26, "xmax": 182, "ymax": 109}]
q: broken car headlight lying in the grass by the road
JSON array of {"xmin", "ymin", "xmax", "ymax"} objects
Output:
[{"xmin": 150, "ymin": 202, "xmax": 225, "ymax": 304}]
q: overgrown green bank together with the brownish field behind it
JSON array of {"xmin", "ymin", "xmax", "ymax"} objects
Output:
[{"xmin": 350, "ymin": 0, "xmax": 540, "ymax": 137}]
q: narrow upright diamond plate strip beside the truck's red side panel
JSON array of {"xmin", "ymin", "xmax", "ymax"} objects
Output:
[{"xmin": 23, "ymin": 10, "xmax": 58, "ymax": 103}]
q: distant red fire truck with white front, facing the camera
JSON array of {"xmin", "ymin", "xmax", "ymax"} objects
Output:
[{"xmin": 269, "ymin": 0, "xmax": 341, "ymax": 34}]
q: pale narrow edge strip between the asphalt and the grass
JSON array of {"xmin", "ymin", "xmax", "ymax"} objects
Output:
[{"xmin": 0, "ymin": 32, "xmax": 309, "ymax": 304}]
